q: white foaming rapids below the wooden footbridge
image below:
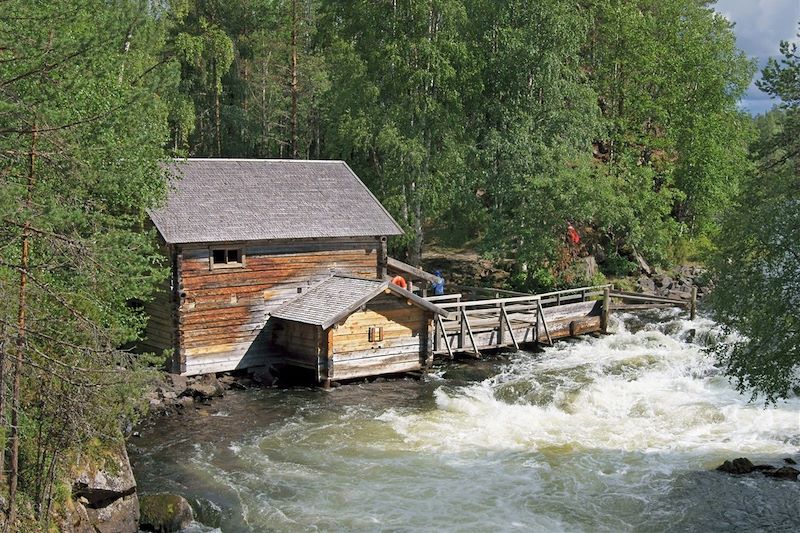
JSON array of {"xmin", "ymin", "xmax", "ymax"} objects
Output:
[{"xmin": 381, "ymin": 313, "xmax": 800, "ymax": 462}]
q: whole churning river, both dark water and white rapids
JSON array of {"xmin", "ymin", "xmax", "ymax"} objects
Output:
[{"xmin": 131, "ymin": 311, "xmax": 800, "ymax": 531}]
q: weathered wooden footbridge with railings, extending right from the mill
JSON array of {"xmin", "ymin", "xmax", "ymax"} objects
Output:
[{"xmin": 426, "ymin": 285, "xmax": 697, "ymax": 358}]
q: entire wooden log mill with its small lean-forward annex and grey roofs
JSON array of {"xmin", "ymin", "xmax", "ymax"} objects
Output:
[{"xmin": 144, "ymin": 159, "xmax": 428, "ymax": 381}]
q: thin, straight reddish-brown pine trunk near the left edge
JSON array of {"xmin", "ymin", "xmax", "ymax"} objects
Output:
[{"xmin": 6, "ymin": 125, "xmax": 37, "ymax": 530}]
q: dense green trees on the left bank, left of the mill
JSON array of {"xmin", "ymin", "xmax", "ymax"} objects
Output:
[{"xmin": 0, "ymin": 0, "xmax": 177, "ymax": 519}]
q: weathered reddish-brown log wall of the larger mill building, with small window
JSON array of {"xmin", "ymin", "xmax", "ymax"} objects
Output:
[{"xmin": 177, "ymin": 239, "xmax": 380, "ymax": 375}]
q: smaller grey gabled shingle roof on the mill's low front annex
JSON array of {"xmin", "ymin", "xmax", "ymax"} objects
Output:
[{"xmin": 270, "ymin": 276, "xmax": 447, "ymax": 329}]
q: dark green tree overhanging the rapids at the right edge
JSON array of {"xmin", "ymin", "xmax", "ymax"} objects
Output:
[{"xmin": 710, "ymin": 21, "xmax": 800, "ymax": 402}]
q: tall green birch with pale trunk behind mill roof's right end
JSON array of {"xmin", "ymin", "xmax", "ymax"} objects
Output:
[{"xmin": 321, "ymin": 0, "xmax": 471, "ymax": 262}]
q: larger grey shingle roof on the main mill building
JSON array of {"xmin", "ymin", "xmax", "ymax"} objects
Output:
[{"xmin": 150, "ymin": 159, "xmax": 403, "ymax": 244}]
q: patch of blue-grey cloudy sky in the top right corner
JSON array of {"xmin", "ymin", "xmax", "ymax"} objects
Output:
[{"xmin": 714, "ymin": 0, "xmax": 800, "ymax": 115}]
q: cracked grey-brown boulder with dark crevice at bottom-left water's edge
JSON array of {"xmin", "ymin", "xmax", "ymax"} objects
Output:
[{"xmin": 72, "ymin": 441, "xmax": 139, "ymax": 533}]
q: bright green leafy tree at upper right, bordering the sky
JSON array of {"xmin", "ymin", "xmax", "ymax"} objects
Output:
[{"xmin": 585, "ymin": 0, "xmax": 753, "ymax": 249}]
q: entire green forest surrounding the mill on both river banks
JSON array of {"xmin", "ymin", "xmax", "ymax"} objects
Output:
[{"xmin": 0, "ymin": 0, "xmax": 800, "ymax": 524}]
